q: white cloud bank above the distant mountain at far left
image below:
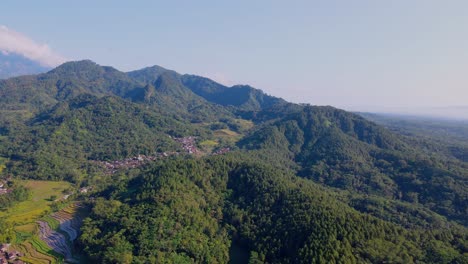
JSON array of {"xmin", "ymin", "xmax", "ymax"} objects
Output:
[{"xmin": 0, "ymin": 25, "xmax": 66, "ymax": 67}]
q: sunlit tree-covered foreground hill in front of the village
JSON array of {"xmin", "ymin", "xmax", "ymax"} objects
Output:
[{"xmin": 80, "ymin": 157, "xmax": 467, "ymax": 263}]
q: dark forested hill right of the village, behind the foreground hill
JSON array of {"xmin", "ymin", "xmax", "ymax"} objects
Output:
[{"xmin": 240, "ymin": 106, "xmax": 468, "ymax": 225}]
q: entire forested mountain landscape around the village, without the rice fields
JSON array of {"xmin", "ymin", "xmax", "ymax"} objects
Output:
[{"xmin": 0, "ymin": 61, "xmax": 468, "ymax": 263}]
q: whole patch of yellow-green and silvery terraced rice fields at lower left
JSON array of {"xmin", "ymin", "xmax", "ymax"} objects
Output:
[{"xmin": 0, "ymin": 181, "xmax": 84, "ymax": 264}]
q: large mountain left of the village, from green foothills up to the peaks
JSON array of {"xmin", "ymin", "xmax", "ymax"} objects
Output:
[{"xmin": 0, "ymin": 60, "xmax": 286, "ymax": 182}]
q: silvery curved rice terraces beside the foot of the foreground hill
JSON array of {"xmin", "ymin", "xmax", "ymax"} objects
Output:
[{"xmin": 38, "ymin": 203, "xmax": 84, "ymax": 262}]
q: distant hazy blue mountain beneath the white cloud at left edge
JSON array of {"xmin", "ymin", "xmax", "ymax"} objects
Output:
[{"xmin": 0, "ymin": 51, "xmax": 50, "ymax": 79}]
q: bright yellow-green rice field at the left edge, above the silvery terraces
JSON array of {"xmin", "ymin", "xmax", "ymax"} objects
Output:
[{"xmin": 0, "ymin": 180, "xmax": 70, "ymax": 232}]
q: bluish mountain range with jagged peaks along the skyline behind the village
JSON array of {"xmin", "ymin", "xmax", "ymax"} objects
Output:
[{"xmin": 0, "ymin": 60, "xmax": 284, "ymax": 121}]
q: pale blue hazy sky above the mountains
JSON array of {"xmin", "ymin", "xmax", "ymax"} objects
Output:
[{"xmin": 0, "ymin": 0, "xmax": 468, "ymax": 115}]
